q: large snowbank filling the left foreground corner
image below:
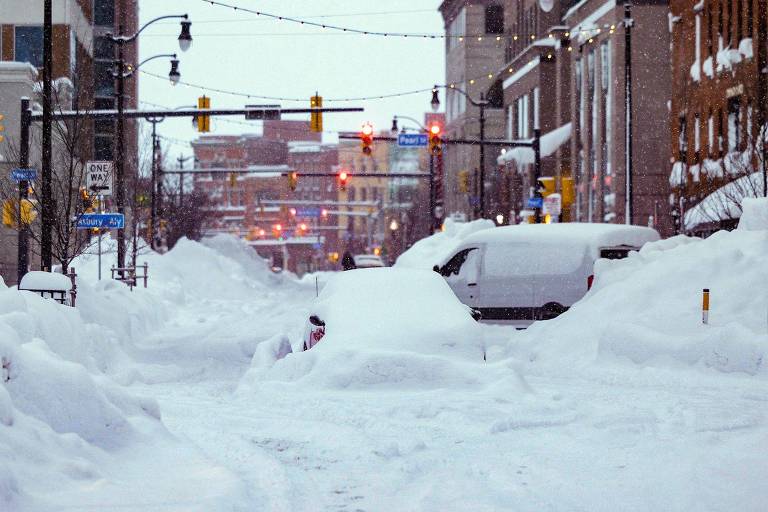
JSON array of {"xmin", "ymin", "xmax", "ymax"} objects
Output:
[{"xmin": 0, "ymin": 274, "xmax": 163, "ymax": 510}]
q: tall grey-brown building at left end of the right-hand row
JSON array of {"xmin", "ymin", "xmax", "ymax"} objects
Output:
[{"xmin": 439, "ymin": 0, "xmax": 506, "ymax": 218}]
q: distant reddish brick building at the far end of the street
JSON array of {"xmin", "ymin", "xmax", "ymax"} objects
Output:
[{"xmin": 192, "ymin": 121, "xmax": 338, "ymax": 274}]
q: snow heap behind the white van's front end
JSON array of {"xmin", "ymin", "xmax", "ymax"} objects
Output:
[{"xmin": 395, "ymin": 219, "xmax": 496, "ymax": 269}]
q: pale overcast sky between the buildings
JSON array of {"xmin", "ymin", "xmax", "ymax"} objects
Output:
[{"xmin": 139, "ymin": 0, "xmax": 445, "ymax": 157}]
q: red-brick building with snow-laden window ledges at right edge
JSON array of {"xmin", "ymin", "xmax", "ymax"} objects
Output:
[{"xmin": 669, "ymin": 0, "xmax": 768, "ymax": 234}]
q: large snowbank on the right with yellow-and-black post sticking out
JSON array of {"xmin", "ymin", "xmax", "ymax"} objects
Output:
[{"xmin": 510, "ymin": 218, "xmax": 768, "ymax": 376}]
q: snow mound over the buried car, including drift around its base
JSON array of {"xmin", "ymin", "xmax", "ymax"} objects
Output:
[{"xmin": 243, "ymin": 268, "xmax": 498, "ymax": 389}]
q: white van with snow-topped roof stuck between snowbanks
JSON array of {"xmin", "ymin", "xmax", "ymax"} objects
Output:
[{"xmin": 434, "ymin": 223, "xmax": 659, "ymax": 327}]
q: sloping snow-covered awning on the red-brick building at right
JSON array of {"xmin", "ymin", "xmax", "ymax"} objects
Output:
[{"xmin": 684, "ymin": 172, "xmax": 763, "ymax": 230}]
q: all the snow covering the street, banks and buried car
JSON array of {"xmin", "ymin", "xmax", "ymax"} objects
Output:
[{"xmin": 0, "ymin": 226, "xmax": 768, "ymax": 512}]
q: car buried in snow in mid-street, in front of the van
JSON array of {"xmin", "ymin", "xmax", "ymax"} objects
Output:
[{"xmin": 303, "ymin": 267, "xmax": 483, "ymax": 360}]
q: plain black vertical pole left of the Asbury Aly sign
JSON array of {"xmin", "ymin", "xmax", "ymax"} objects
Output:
[{"xmin": 41, "ymin": 0, "xmax": 54, "ymax": 270}]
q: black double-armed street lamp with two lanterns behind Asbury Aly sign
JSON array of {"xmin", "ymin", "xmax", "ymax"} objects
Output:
[{"xmin": 107, "ymin": 14, "xmax": 192, "ymax": 268}]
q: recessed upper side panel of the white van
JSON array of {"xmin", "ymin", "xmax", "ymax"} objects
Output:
[{"xmin": 483, "ymin": 243, "xmax": 587, "ymax": 277}]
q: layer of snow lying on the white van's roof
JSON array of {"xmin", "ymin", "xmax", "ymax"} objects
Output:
[{"xmin": 462, "ymin": 222, "xmax": 660, "ymax": 247}]
